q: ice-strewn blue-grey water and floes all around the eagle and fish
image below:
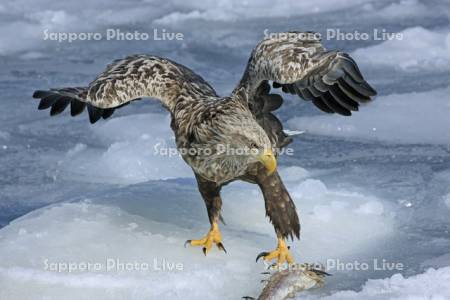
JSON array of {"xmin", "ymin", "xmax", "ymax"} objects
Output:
[{"xmin": 0, "ymin": 0, "xmax": 450, "ymax": 299}]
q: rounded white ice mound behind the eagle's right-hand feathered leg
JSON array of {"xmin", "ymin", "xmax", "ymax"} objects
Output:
[{"xmin": 223, "ymin": 176, "xmax": 393, "ymax": 261}]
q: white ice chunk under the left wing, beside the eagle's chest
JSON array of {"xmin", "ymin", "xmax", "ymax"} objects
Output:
[{"xmin": 58, "ymin": 114, "xmax": 193, "ymax": 184}]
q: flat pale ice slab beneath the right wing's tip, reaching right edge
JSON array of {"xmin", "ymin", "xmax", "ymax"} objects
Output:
[{"xmin": 288, "ymin": 85, "xmax": 450, "ymax": 145}]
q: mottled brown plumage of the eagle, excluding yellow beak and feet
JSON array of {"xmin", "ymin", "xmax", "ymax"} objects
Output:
[{"xmin": 33, "ymin": 35, "xmax": 375, "ymax": 253}]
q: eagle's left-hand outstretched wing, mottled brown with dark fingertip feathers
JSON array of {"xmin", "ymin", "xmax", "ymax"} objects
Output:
[{"xmin": 33, "ymin": 55, "xmax": 216, "ymax": 123}]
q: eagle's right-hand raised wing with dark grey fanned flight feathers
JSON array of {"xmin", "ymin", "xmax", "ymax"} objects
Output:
[{"xmin": 234, "ymin": 32, "xmax": 376, "ymax": 147}]
